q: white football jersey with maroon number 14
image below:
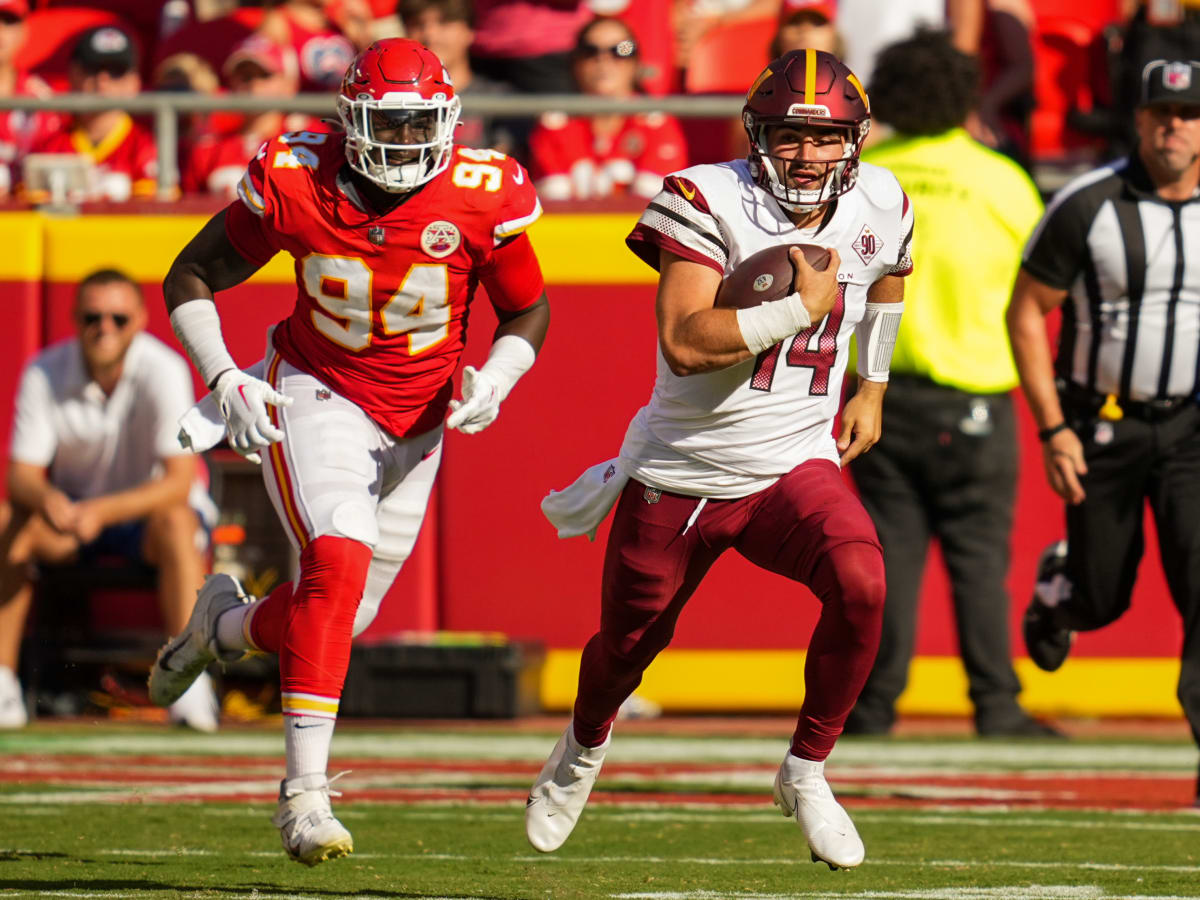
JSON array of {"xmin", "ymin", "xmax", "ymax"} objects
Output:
[{"xmin": 620, "ymin": 160, "xmax": 913, "ymax": 498}]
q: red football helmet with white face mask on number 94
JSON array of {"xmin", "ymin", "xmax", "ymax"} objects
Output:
[{"xmin": 337, "ymin": 37, "xmax": 462, "ymax": 192}]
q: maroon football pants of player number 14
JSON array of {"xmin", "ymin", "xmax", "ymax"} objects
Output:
[{"xmin": 574, "ymin": 460, "xmax": 884, "ymax": 760}]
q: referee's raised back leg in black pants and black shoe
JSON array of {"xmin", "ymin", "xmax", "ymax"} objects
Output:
[{"xmin": 1021, "ymin": 407, "xmax": 1156, "ymax": 672}]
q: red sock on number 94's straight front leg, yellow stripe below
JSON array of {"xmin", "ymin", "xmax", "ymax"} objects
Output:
[{"xmin": 276, "ymin": 535, "xmax": 371, "ymax": 715}]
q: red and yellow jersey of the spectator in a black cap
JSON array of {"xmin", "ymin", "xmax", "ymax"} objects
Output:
[{"xmin": 34, "ymin": 114, "xmax": 158, "ymax": 203}]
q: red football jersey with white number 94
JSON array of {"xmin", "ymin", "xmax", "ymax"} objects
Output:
[{"xmin": 226, "ymin": 132, "xmax": 542, "ymax": 437}]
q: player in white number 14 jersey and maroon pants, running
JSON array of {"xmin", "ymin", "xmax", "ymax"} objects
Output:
[{"xmin": 526, "ymin": 50, "xmax": 912, "ymax": 868}]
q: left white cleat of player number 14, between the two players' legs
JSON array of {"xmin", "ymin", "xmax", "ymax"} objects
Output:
[{"xmin": 526, "ymin": 725, "xmax": 612, "ymax": 853}]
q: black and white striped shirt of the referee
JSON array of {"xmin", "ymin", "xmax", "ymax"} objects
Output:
[{"xmin": 1024, "ymin": 154, "xmax": 1200, "ymax": 401}]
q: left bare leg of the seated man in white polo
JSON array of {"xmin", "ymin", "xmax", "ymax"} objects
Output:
[{"xmin": 0, "ymin": 502, "xmax": 79, "ymax": 728}]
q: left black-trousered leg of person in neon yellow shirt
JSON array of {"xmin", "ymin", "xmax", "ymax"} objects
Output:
[{"xmin": 846, "ymin": 412, "xmax": 930, "ymax": 734}]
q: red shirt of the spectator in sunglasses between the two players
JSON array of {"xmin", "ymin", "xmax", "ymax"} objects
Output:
[{"xmin": 529, "ymin": 113, "xmax": 688, "ymax": 200}]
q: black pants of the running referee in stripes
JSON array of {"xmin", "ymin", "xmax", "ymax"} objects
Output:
[{"xmin": 1055, "ymin": 395, "xmax": 1200, "ymax": 743}]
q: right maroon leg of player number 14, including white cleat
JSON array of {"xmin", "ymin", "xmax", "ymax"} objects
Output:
[{"xmin": 734, "ymin": 460, "xmax": 886, "ymax": 868}]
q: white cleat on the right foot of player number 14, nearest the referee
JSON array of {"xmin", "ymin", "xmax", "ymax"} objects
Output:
[{"xmin": 775, "ymin": 752, "xmax": 866, "ymax": 869}]
